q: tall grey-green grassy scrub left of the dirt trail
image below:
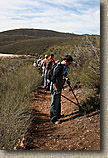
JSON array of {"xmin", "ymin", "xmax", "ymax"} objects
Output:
[{"xmin": 0, "ymin": 59, "xmax": 41, "ymax": 150}]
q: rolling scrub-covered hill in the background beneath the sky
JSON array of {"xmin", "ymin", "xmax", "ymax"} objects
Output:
[{"xmin": 0, "ymin": 29, "xmax": 98, "ymax": 56}]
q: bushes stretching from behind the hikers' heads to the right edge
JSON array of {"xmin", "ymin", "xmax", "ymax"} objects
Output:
[{"xmin": 47, "ymin": 36, "xmax": 100, "ymax": 112}]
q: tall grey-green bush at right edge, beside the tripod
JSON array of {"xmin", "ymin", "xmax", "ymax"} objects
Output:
[{"xmin": 69, "ymin": 38, "xmax": 100, "ymax": 111}]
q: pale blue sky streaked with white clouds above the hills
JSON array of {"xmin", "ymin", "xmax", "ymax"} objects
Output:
[{"xmin": 0, "ymin": 0, "xmax": 100, "ymax": 34}]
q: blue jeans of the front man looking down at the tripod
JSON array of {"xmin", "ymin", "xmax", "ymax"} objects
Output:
[{"xmin": 50, "ymin": 84, "xmax": 61, "ymax": 123}]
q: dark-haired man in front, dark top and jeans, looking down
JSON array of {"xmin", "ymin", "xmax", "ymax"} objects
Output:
[{"xmin": 50, "ymin": 55, "xmax": 73, "ymax": 124}]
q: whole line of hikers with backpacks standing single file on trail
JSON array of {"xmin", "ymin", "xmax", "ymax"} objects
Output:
[{"xmin": 34, "ymin": 54, "xmax": 73, "ymax": 124}]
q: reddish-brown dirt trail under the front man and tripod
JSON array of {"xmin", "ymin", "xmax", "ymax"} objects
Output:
[{"xmin": 25, "ymin": 87, "xmax": 100, "ymax": 150}]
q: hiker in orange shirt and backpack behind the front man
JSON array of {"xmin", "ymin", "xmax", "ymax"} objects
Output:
[{"xmin": 43, "ymin": 54, "xmax": 55, "ymax": 90}]
